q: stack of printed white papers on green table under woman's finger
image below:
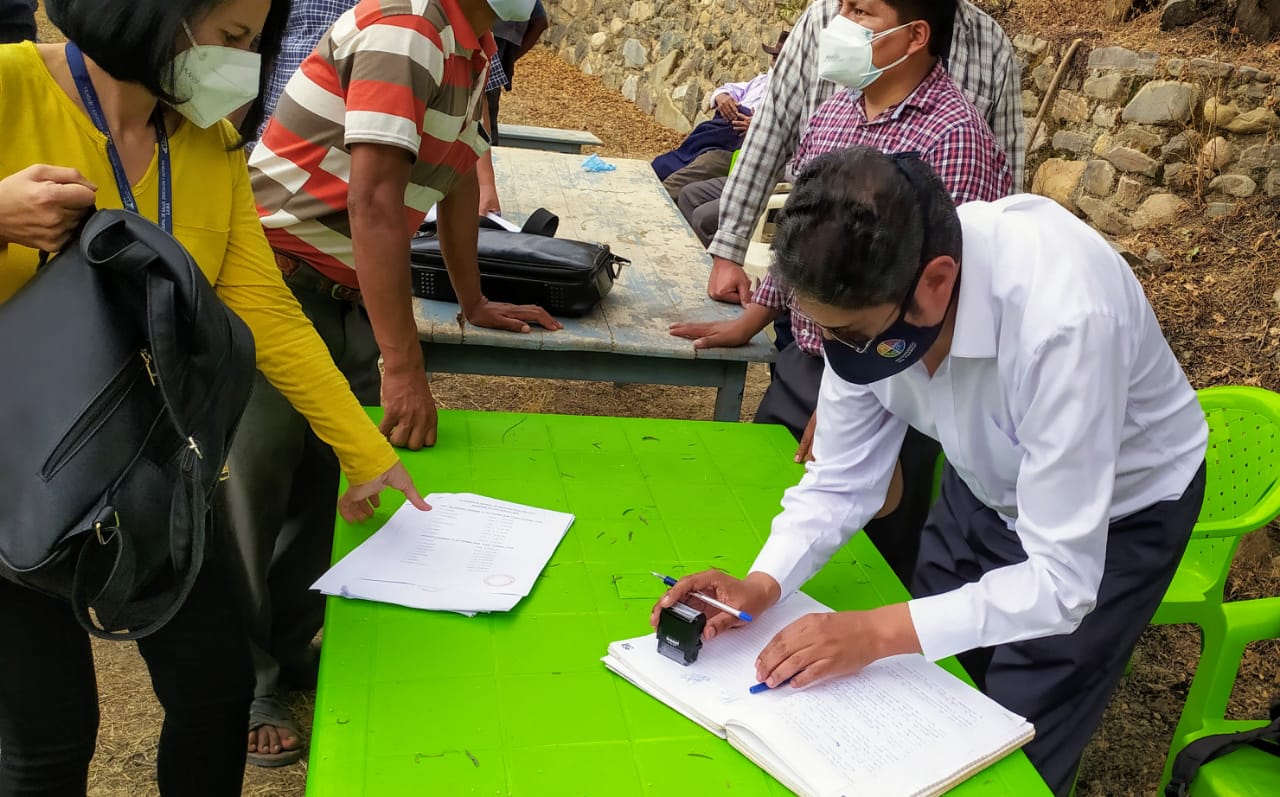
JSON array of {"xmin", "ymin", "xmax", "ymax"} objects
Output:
[{"xmin": 311, "ymin": 493, "xmax": 573, "ymax": 614}]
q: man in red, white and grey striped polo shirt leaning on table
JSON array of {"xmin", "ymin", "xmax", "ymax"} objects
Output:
[{"xmin": 229, "ymin": 0, "xmax": 561, "ymax": 766}]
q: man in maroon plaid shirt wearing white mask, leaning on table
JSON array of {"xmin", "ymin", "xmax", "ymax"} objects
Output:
[{"xmin": 671, "ymin": 0, "xmax": 1012, "ymax": 583}]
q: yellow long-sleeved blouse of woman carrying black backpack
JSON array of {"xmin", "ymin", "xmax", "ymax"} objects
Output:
[{"xmin": 0, "ymin": 43, "xmax": 397, "ymax": 484}]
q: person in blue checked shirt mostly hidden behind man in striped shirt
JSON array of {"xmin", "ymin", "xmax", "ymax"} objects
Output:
[{"xmin": 249, "ymin": 0, "xmax": 508, "ymax": 216}]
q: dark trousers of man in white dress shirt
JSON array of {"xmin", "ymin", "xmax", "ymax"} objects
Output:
[{"xmin": 911, "ymin": 467, "xmax": 1204, "ymax": 797}]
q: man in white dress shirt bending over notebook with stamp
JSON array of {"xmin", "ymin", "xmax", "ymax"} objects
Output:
[{"xmin": 654, "ymin": 148, "xmax": 1208, "ymax": 796}]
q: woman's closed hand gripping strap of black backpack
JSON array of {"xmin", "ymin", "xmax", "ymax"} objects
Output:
[{"xmin": 0, "ymin": 164, "xmax": 97, "ymax": 252}]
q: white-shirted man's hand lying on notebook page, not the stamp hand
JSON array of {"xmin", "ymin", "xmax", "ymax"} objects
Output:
[{"xmin": 755, "ymin": 603, "xmax": 920, "ymax": 688}]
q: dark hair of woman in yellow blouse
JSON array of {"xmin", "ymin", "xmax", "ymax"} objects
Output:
[{"xmin": 45, "ymin": 0, "xmax": 292, "ymax": 145}]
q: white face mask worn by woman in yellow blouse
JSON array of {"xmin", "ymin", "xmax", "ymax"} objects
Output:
[{"xmin": 169, "ymin": 22, "xmax": 262, "ymax": 128}]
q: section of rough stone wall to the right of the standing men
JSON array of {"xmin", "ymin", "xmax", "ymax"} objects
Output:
[{"xmin": 1014, "ymin": 36, "xmax": 1280, "ymax": 235}]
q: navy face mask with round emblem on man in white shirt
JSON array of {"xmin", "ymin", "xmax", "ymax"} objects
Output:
[{"xmin": 822, "ymin": 152, "xmax": 960, "ymax": 385}]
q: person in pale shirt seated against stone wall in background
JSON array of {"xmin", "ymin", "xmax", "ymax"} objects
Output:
[{"xmin": 653, "ymin": 31, "xmax": 787, "ymax": 202}]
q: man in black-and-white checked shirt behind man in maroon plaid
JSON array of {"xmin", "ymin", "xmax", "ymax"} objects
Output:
[{"xmin": 707, "ymin": 0, "xmax": 1027, "ymax": 304}]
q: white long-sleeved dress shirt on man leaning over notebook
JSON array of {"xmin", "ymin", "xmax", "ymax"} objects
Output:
[{"xmin": 751, "ymin": 194, "xmax": 1208, "ymax": 659}]
